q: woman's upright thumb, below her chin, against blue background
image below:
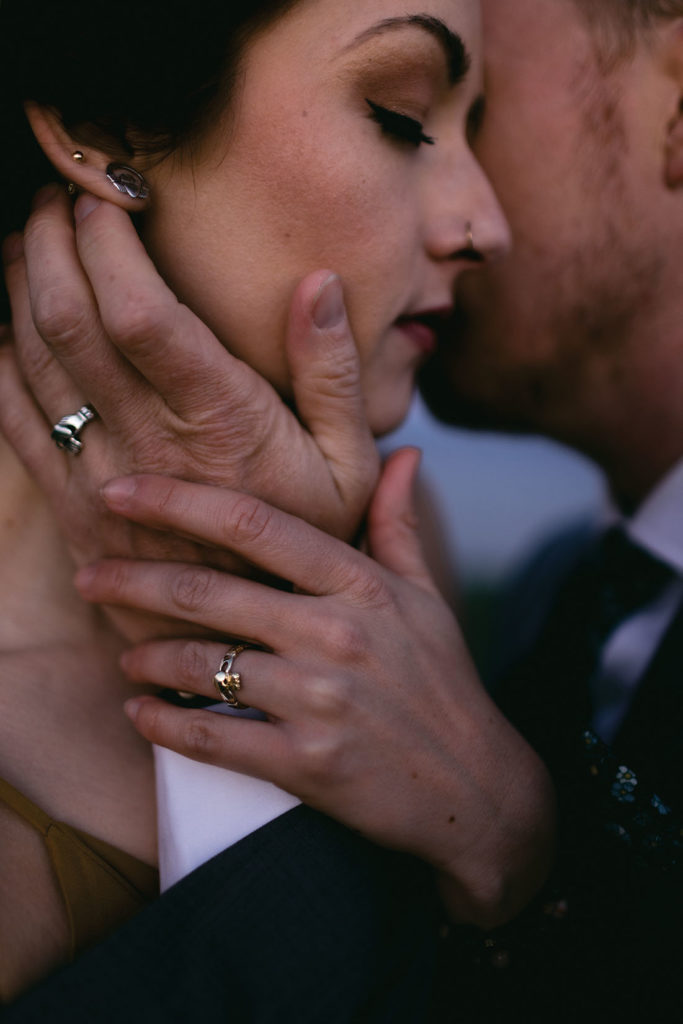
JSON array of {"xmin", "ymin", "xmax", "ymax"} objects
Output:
[{"xmin": 368, "ymin": 449, "xmax": 437, "ymax": 594}]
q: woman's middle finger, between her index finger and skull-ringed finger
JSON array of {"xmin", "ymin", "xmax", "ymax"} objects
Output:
[{"xmin": 76, "ymin": 559, "xmax": 307, "ymax": 650}]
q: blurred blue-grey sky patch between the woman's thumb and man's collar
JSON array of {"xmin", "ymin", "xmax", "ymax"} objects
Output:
[{"xmin": 382, "ymin": 399, "xmax": 605, "ymax": 585}]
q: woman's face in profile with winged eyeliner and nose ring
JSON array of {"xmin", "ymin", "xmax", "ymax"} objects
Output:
[{"xmin": 144, "ymin": 0, "xmax": 507, "ymax": 433}]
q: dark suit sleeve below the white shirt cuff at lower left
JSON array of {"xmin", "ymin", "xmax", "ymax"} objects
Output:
[{"xmin": 3, "ymin": 807, "xmax": 436, "ymax": 1024}]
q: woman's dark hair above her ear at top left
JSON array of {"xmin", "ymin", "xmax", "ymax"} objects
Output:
[{"xmin": 0, "ymin": 0, "xmax": 297, "ymax": 323}]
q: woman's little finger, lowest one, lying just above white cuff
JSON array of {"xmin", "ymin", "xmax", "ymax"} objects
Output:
[{"xmin": 125, "ymin": 696, "xmax": 293, "ymax": 790}]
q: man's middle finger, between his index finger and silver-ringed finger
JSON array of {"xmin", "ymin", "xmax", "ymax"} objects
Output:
[{"xmin": 23, "ymin": 189, "xmax": 140, "ymax": 421}]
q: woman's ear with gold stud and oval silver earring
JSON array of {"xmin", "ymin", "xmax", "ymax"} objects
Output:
[{"xmin": 25, "ymin": 101, "xmax": 148, "ymax": 212}]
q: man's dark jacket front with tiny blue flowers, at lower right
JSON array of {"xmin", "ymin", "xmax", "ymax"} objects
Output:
[{"xmin": 435, "ymin": 540, "xmax": 683, "ymax": 1024}]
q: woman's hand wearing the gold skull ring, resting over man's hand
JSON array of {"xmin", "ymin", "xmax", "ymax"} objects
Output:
[{"xmin": 77, "ymin": 452, "xmax": 554, "ymax": 927}]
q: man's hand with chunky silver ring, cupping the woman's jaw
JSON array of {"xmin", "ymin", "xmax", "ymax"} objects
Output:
[{"xmin": 0, "ymin": 186, "xmax": 379, "ymax": 622}]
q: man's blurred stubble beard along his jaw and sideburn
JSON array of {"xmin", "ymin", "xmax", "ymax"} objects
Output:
[{"xmin": 421, "ymin": 58, "xmax": 663, "ymax": 454}]
